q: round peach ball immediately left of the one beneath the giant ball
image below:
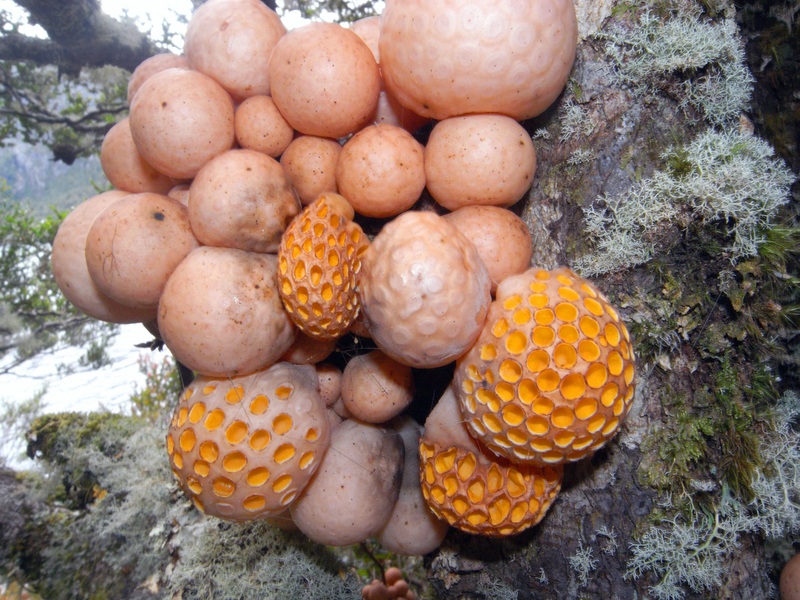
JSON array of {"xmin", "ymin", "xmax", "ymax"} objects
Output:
[{"xmin": 336, "ymin": 125, "xmax": 425, "ymax": 217}]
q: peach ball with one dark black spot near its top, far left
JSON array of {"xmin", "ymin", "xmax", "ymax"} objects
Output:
[{"xmin": 85, "ymin": 193, "xmax": 200, "ymax": 308}]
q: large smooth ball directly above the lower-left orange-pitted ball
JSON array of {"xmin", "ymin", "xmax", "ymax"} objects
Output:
[{"xmin": 158, "ymin": 246, "xmax": 297, "ymax": 376}]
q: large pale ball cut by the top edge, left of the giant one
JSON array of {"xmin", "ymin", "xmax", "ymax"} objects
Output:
[{"xmin": 183, "ymin": 0, "xmax": 286, "ymax": 99}]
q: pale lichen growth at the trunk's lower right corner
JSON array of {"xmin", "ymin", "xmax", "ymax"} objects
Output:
[{"xmin": 625, "ymin": 392, "xmax": 800, "ymax": 600}]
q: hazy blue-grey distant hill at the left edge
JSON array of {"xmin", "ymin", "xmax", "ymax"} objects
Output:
[{"xmin": 0, "ymin": 143, "xmax": 110, "ymax": 216}]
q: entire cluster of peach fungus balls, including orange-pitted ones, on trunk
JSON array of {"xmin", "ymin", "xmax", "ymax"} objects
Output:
[{"xmin": 53, "ymin": 0, "xmax": 634, "ymax": 564}]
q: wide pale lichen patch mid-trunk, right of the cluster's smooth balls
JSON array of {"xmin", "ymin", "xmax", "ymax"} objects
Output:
[{"xmin": 574, "ymin": 130, "xmax": 794, "ymax": 277}]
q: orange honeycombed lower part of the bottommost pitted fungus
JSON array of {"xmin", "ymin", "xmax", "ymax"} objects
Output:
[{"xmin": 419, "ymin": 436, "xmax": 562, "ymax": 537}]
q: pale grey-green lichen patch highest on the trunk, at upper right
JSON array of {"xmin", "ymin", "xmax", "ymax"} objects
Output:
[{"xmin": 602, "ymin": 7, "xmax": 754, "ymax": 126}]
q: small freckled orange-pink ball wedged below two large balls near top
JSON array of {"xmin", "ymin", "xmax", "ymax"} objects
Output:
[{"xmin": 234, "ymin": 96, "xmax": 294, "ymax": 158}]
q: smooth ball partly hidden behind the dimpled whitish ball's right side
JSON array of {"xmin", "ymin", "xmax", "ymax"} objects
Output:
[{"xmin": 444, "ymin": 206, "xmax": 533, "ymax": 294}]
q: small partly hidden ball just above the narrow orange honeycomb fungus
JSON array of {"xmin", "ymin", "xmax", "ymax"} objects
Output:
[{"xmin": 281, "ymin": 135, "xmax": 342, "ymax": 206}]
